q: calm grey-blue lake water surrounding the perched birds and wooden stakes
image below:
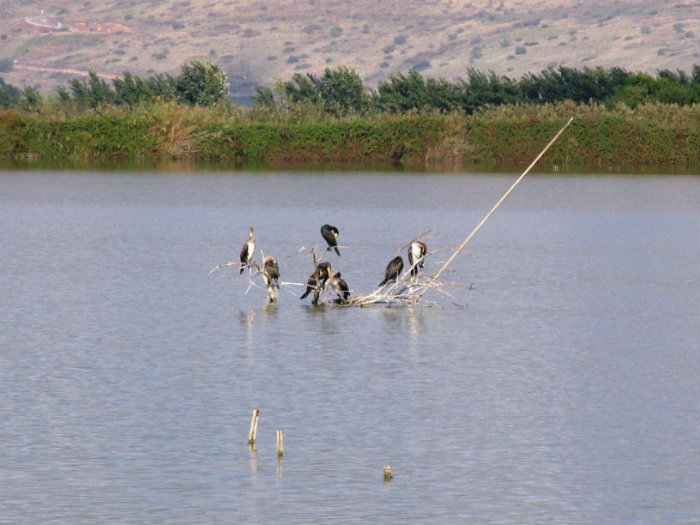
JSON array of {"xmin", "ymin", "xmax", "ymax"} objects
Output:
[{"xmin": 0, "ymin": 171, "xmax": 700, "ymax": 525}]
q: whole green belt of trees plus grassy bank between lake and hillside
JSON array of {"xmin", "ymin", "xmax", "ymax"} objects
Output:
[{"xmin": 0, "ymin": 62, "xmax": 700, "ymax": 169}]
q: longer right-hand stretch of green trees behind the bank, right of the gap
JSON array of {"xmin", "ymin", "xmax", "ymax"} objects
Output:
[{"xmin": 253, "ymin": 65, "xmax": 700, "ymax": 116}]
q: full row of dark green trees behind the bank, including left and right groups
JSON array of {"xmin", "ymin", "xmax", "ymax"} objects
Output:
[{"xmin": 0, "ymin": 61, "xmax": 700, "ymax": 117}]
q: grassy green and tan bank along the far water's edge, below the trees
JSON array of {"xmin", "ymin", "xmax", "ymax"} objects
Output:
[{"xmin": 0, "ymin": 103, "xmax": 700, "ymax": 168}]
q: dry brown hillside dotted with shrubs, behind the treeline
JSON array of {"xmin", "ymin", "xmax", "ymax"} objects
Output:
[{"xmin": 0, "ymin": 0, "xmax": 700, "ymax": 102}]
